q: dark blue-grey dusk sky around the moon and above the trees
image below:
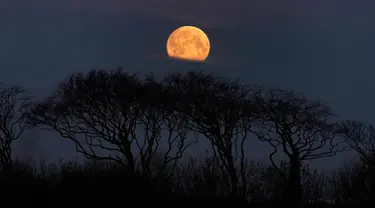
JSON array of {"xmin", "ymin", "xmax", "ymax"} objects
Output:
[{"xmin": 0, "ymin": 0, "xmax": 375, "ymax": 167}]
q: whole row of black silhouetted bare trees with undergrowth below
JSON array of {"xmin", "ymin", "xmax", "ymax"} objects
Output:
[{"xmin": 0, "ymin": 69, "xmax": 375, "ymax": 206}]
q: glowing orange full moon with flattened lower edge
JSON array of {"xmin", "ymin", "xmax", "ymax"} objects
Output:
[{"xmin": 167, "ymin": 26, "xmax": 210, "ymax": 61}]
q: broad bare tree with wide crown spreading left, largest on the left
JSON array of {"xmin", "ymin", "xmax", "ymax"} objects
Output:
[{"xmin": 29, "ymin": 70, "xmax": 194, "ymax": 174}]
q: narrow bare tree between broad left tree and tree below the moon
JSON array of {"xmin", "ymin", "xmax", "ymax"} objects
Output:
[{"xmin": 135, "ymin": 75, "xmax": 197, "ymax": 178}]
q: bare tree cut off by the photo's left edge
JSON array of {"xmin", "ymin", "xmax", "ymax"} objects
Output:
[{"xmin": 0, "ymin": 83, "xmax": 31, "ymax": 170}]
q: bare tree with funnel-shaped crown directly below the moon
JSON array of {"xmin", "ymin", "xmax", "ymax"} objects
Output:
[{"xmin": 163, "ymin": 72, "xmax": 262, "ymax": 196}]
